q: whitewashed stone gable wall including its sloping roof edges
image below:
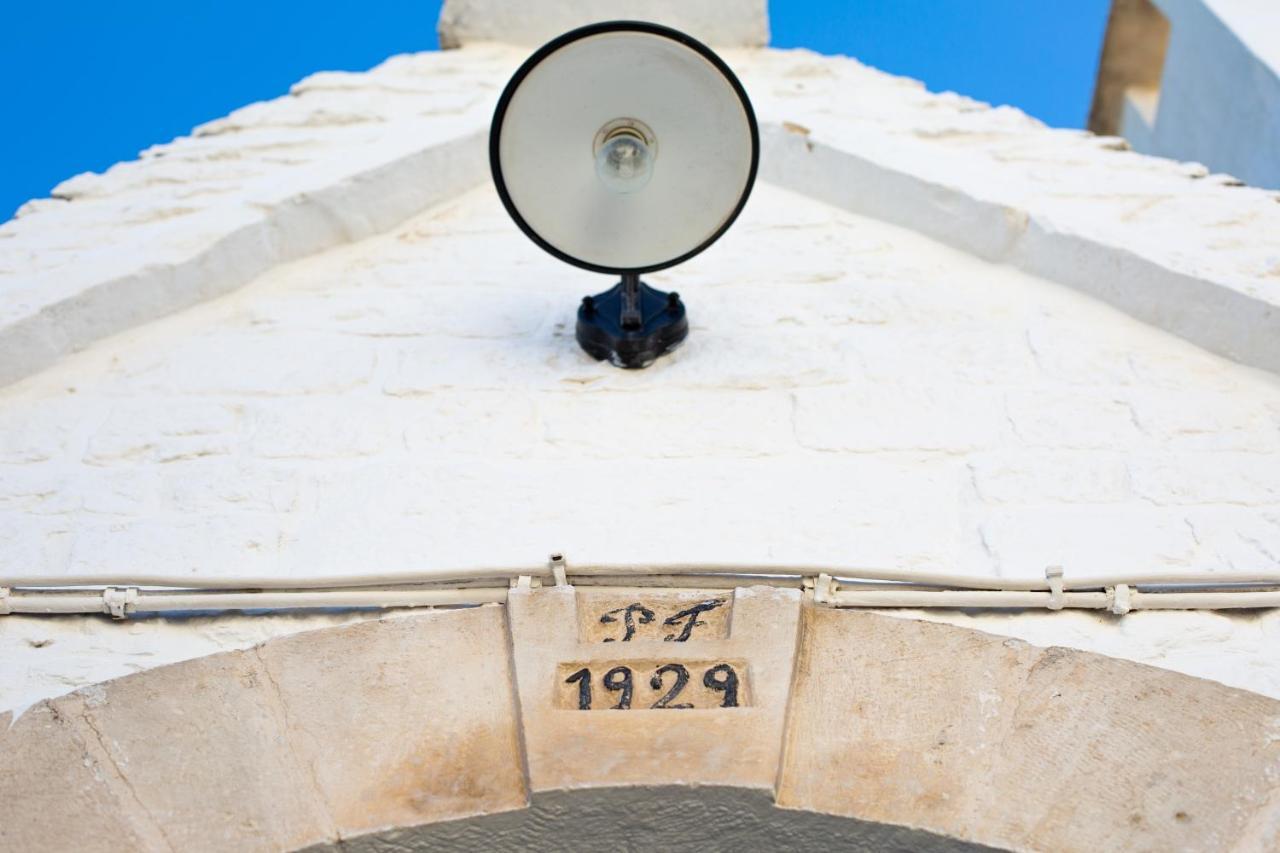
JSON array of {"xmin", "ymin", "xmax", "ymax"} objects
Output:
[{"xmin": 0, "ymin": 39, "xmax": 1280, "ymax": 707}]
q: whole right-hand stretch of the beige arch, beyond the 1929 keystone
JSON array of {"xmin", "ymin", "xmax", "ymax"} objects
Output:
[{"xmin": 778, "ymin": 607, "xmax": 1280, "ymax": 850}]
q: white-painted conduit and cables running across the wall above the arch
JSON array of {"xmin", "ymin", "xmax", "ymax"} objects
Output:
[{"xmin": 0, "ymin": 558, "xmax": 1280, "ymax": 619}]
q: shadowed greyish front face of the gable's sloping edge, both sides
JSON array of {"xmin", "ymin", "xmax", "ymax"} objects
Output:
[{"xmin": 0, "ymin": 69, "xmax": 1280, "ymax": 386}]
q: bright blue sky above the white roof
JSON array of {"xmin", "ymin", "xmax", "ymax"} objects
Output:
[{"xmin": 0, "ymin": 0, "xmax": 1110, "ymax": 220}]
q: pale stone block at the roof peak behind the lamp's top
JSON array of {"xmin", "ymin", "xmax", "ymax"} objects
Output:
[{"xmin": 439, "ymin": 0, "xmax": 769, "ymax": 47}]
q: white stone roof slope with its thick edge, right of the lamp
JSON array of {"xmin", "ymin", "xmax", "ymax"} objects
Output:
[{"xmin": 735, "ymin": 51, "xmax": 1280, "ymax": 371}]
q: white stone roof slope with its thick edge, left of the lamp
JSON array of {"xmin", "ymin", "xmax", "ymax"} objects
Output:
[{"xmin": 0, "ymin": 49, "xmax": 515, "ymax": 384}]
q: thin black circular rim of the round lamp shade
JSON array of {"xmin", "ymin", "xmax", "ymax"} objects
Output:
[{"xmin": 489, "ymin": 20, "xmax": 760, "ymax": 275}]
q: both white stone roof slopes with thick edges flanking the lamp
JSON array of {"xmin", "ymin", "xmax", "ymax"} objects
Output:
[{"xmin": 0, "ymin": 45, "xmax": 1280, "ymax": 384}]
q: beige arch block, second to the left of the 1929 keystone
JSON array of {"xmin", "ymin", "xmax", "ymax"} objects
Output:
[{"xmin": 47, "ymin": 651, "xmax": 333, "ymax": 850}]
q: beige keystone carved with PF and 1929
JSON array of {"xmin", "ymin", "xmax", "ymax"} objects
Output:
[{"xmin": 508, "ymin": 587, "xmax": 800, "ymax": 792}]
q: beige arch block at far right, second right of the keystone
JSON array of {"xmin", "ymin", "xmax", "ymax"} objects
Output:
[{"xmin": 978, "ymin": 648, "xmax": 1280, "ymax": 850}]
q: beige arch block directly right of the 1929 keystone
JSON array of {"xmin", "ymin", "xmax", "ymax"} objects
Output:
[{"xmin": 778, "ymin": 607, "xmax": 1036, "ymax": 831}]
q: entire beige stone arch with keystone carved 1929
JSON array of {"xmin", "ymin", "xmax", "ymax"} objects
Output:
[{"xmin": 0, "ymin": 587, "xmax": 1280, "ymax": 850}]
